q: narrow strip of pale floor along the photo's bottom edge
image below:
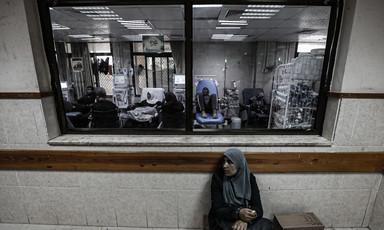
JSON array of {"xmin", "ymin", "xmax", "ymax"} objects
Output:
[{"xmin": 0, "ymin": 223, "xmax": 369, "ymax": 230}]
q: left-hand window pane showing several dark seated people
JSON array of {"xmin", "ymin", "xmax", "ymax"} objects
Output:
[{"xmin": 50, "ymin": 5, "xmax": 186, "ymax": 130}]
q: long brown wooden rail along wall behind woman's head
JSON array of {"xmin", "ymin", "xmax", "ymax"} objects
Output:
[{"xmin": 0, "ymin": 150, "xmax": 384, "ymax": 172}]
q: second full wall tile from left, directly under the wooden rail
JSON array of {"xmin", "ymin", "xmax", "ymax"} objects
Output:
[{"xmin": 79, "ymin": 172, "xmax": 146, "ymax": 189}]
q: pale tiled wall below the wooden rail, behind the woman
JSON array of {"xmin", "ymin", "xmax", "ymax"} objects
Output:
[{"xmin": 0, "ymin": 171, "xmax": 383, "ymax": 229}]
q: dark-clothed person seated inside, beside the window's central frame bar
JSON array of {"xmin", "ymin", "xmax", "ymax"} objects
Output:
[{"xmin": 161, "ymin": 92, "xmax": 185, "ymax": 128}]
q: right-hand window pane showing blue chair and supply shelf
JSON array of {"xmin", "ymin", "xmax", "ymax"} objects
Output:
[{"xmin": 192, "ymin": 4, "xmax": 331, "ymax": 131}]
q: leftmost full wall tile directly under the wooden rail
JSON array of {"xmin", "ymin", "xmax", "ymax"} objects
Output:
[{"xmin": 17, "ymin": 171, "xmax": 82, "ymax": 187}]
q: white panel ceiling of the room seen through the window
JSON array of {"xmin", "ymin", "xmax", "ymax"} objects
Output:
[{"xmin": 50, "ymin": 5, "xmax": 330, "ymax": 42}]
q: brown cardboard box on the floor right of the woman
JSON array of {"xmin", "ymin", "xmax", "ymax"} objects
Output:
[{"xmin": 273, "ymin": 213, "xmax": 324, "ymax": 230}]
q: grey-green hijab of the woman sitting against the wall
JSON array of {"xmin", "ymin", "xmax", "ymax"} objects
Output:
[{"xmin": 223, "ymin": 148, "xmax": 251, "ymax": 205}]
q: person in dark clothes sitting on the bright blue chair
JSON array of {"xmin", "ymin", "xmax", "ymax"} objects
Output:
[{"xmin": 196, "ymin": 87, "xmax": 218, "ymax": 119}]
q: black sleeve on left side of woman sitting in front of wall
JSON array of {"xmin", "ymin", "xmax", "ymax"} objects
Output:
[{"xmin": 211, "ymin": 173, "xmax": 241, "ymax": 220}]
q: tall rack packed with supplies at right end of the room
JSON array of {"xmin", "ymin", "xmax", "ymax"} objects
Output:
[{"xmin": 268, "ymin": 49, "xmax": 324, "ymax": 129}]
